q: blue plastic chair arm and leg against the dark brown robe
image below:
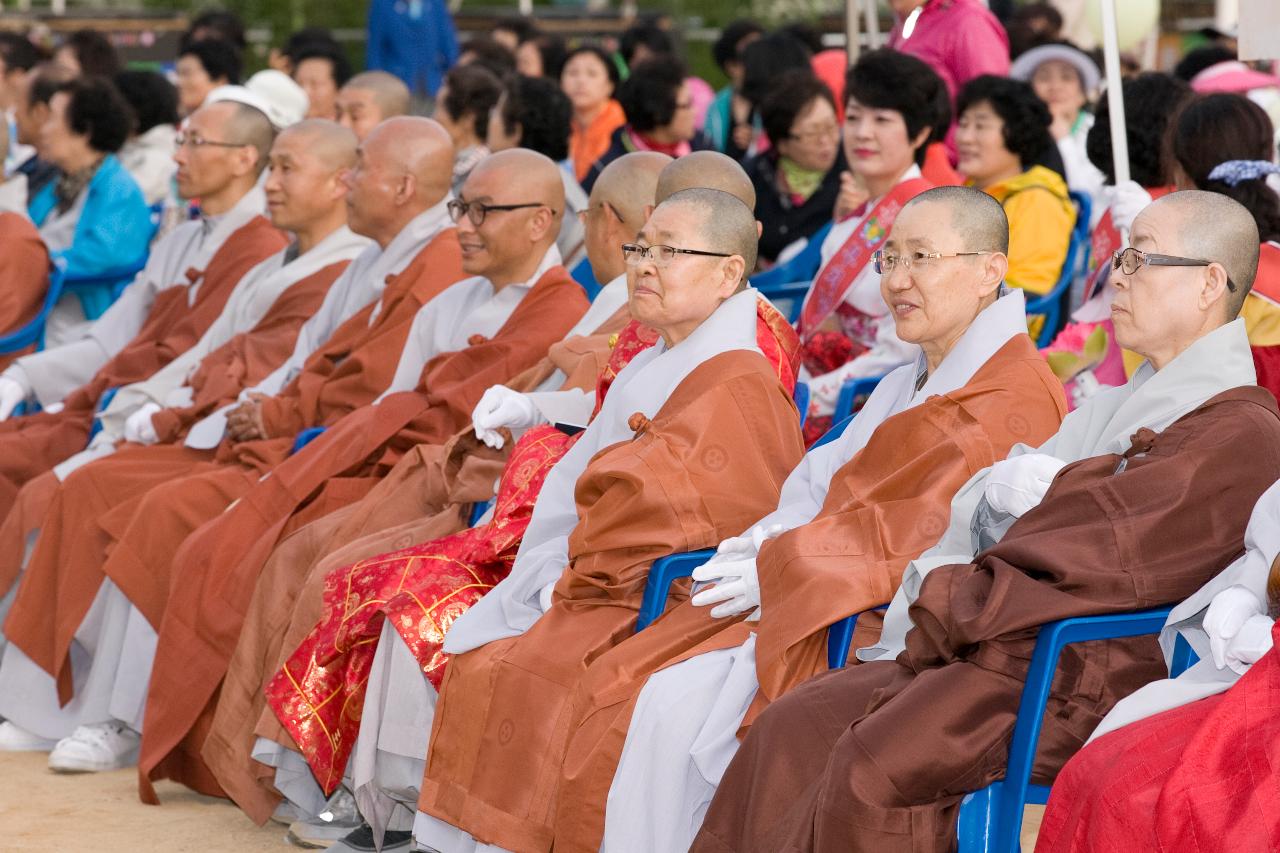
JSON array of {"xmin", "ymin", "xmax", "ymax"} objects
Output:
[{"xmin": 956, "ymin": 607, "xmax": 1172, "ymax": 853}]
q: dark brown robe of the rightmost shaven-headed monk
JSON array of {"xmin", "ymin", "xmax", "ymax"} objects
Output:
[{"xmin": 694, "ymin": 388, "xmax": 1280, "ymax": 853}]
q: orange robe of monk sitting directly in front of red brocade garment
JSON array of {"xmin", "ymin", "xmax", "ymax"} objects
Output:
[{"xmin": 419, "ymin": 350, "xmax": 804, "ymax": 850}]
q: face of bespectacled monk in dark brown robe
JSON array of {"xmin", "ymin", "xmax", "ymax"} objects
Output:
[{"xmin": 1111, "ymin": 204, "xmax": 1226, "ymax": 368}]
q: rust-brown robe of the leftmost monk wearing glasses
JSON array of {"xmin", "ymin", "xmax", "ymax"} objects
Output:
[{"xmin": 0, "ymin": 216, "xmax": 287, "ymax": 517}]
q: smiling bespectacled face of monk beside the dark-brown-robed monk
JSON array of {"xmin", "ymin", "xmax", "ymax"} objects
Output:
[{"xmin": 881, "ymin": 201, "xmax": 1004, "ymax": 369}]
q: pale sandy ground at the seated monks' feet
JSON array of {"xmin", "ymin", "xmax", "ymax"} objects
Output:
[{"xmin": 0, "ymin": 752, "xmax": 1044, "ymax": 853}]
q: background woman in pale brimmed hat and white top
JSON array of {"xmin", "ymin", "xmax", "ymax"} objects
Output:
[{"xmin": 1009, "ymin": 44, "xmax": 1105, "ymax": 222}]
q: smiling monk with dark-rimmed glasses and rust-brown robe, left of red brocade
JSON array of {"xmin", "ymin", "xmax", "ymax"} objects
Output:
[{"xmin": 129, "ymin": 144, "xmax": 588, "ymax": 795}]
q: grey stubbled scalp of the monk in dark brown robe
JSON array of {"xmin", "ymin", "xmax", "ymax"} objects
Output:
[{"xmin": 1162, "ymin": 190, "xmax": 1261, "ymax": 320}]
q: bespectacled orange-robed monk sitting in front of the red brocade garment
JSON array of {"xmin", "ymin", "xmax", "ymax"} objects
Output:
[{"xmin": 414, "ymin": 190, "xmax": 803, "ymax": 850}]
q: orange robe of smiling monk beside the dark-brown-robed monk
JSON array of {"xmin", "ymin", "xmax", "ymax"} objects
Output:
[{"xmin": 554, "ymin": 334, "xmax": 1066, "ymax": 850}]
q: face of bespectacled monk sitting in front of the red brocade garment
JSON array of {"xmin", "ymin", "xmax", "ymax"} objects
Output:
[{"xmin": 627, "ymin": 202, "xmax": 744, "ymax": 346}]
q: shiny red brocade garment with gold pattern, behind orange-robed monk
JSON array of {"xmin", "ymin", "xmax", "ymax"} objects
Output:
[{"xmin": 258, "ymin": 300, "xmax": 799, "ymax": 793}]
